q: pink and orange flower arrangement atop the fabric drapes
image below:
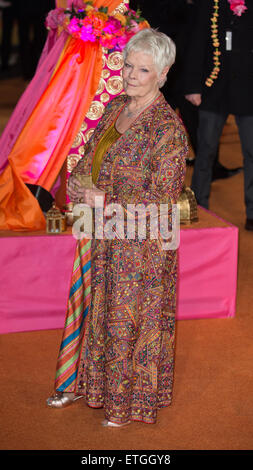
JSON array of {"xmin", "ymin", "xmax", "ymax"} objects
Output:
[{"xmin": 46, "ymin": 0, "xmax": 149, "ymax": 50}]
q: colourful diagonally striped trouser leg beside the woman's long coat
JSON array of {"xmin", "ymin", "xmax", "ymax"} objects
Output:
[{"xmin": 55, "ymin": 239, "xmax": 91, "ymax": 392}]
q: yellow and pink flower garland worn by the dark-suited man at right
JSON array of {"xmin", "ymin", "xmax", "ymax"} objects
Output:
[{"xmin": 205, "ymin": 0, "xmax": 247, "ymax": 87}]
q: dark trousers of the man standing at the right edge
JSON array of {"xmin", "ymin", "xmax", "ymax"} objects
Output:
[{"xmin": 191, "ymin": 110, "xmax": 253, "ymax": 219}]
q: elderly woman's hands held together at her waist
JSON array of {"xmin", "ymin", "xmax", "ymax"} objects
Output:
[{"xmin": 67, "ymin": 176, "xmax": 105, "ymax": 207}]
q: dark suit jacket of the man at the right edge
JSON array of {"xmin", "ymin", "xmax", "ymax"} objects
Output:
[{"xmin": 184, "ymin": 0, "xmax": 253, "ymax": 115}]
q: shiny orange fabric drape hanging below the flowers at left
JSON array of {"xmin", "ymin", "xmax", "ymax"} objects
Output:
[{"xmin": 0, "ymin": 0, "xmax": 121, "ymax": 231}]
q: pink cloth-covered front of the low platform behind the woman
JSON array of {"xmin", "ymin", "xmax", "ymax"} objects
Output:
[{"xmin": 0, "ymin": 209, "xmax": 238, "ymax": 333}]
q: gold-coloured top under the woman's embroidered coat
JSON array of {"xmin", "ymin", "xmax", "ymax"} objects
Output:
[{"xmin": 92, "ymin": 123, "xmax": 121, "ymax": 184}]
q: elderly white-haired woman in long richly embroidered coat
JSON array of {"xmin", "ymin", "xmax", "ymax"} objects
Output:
[{"xmin": 48, "ymin": 29, "xmax": 188, "ymax": 426}]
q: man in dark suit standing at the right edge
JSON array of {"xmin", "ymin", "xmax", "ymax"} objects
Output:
[{"xmin": 185, "ymin": 0, "xmax": 253, "ymax": 230}]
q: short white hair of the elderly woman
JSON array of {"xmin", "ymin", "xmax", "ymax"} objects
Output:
[{"xmin": 123, "ymin": 28, "xmax": 176, "ymax": 75}]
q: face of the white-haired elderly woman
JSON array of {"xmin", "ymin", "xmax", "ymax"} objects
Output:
[{"xmin": 122, "ymin": 51, "xmax": 162, "ymax": 98}]
